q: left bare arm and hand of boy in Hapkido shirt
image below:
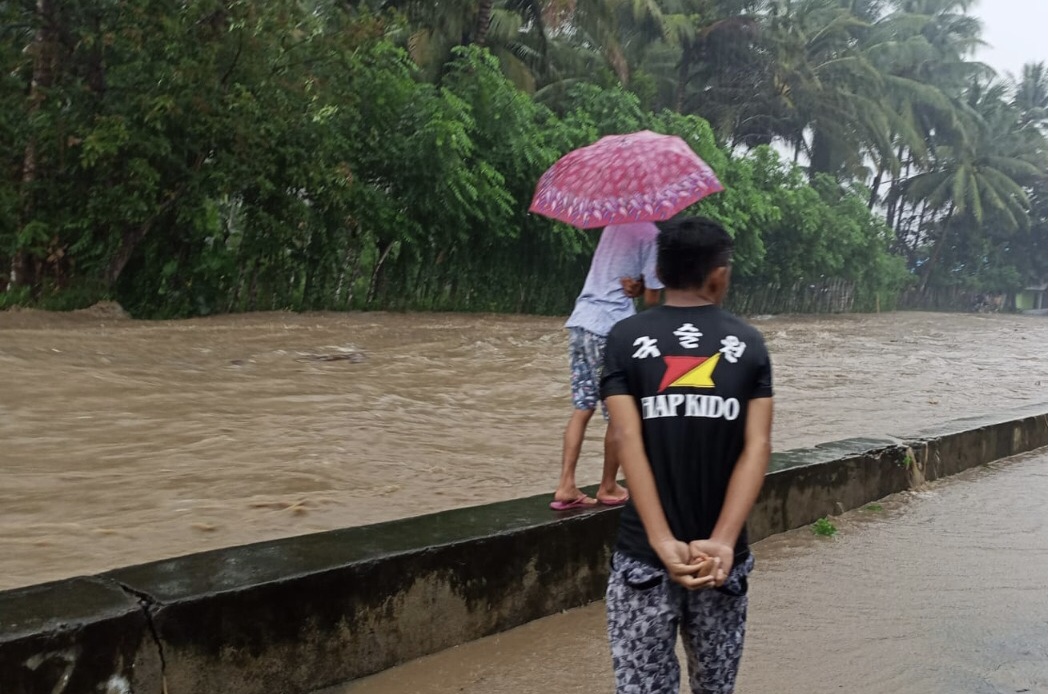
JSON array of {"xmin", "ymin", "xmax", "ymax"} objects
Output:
[{"xmin": 605, "ymin": 394, "xmax": 716, "ymax": 590}]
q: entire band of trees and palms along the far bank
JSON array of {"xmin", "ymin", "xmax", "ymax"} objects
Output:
[{"xmin": 0, "ymin": 0, "xmax": 1035, "ymax": 317}]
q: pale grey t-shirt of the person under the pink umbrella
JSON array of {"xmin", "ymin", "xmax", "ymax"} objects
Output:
[{"xmin": 565, "ymin": 222, "xmax": 662, "ymax": 337}]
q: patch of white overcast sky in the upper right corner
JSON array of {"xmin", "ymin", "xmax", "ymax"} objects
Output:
[{"xmin": 970, "ymin": 0, "xmax": 1048, "ymax": 77}]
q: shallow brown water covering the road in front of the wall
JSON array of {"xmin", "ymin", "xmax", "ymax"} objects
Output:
[{"xmin": 337, "ymin": 452, "xmax": 1048, "ymax": 694}]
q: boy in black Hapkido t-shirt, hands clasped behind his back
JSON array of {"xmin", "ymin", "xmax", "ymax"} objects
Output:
[{"xmin": 602, "ymin": 217, "xmax": 771, "ymax": 694}]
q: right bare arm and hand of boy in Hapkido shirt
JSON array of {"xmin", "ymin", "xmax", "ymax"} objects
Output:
[{"xmin": 691, "ymin": 397, "xmax": 772, "ymax": 586}]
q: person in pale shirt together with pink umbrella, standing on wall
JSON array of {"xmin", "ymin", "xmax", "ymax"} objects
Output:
[{"xmin": 530, "ymin": 130, "xmax": 724, "ymax": 511}]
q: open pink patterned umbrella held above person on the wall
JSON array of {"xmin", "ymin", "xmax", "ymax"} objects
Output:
[{"xmin": 530, "ymin": 130, "xmax": 724, "ymax": 229}]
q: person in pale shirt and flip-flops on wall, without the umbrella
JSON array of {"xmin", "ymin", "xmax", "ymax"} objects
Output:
[{"xmin": 550, "ymin": 222, "xmax": 662, "ymax": 511}]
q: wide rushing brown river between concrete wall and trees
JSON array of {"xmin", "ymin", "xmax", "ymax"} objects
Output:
[{"xmin": 0, "ymin": 307, "xmax": 1048, "ymax": 588}]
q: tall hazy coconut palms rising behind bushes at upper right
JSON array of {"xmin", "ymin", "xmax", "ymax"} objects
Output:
[{"xmin": 574, "ymin": 0, "xmax": 1048, "ymax": 295}]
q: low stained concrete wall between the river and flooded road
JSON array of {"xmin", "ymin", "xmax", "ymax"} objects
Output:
[{"xmin": 6, "ymin": 405, "xmax": 1048, "ymax": 694}]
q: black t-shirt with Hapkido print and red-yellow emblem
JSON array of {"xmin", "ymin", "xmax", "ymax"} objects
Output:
[{"xmin": 601, "ymin": 306, "xmax": 771, "ymax": 566}]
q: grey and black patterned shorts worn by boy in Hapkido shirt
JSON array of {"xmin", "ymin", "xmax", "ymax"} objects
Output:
[{"xmin": 607, "ymin": 552, "xmax": 754, "ymax": 694}]
